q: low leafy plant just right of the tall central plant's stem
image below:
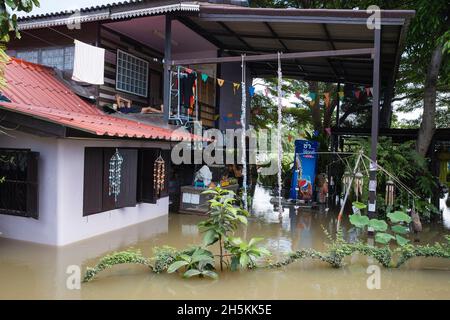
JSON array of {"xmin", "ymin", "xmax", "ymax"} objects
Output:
[{"xmin": 225, "ymin": 237, "xmax": 271, "ymax": 271}]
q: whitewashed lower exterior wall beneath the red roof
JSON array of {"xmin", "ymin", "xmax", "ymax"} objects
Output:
[{"xmin": 0, "ymin": 132, "xmax": 169, "ymax": 246}]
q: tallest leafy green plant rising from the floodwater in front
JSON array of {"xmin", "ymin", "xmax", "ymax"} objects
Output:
[{"xmin": 198, "ymin": 187, "xmax": 248, "ymax": 271}]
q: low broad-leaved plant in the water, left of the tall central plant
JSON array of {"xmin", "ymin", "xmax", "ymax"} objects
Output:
[{"xmin": 167, "ymin": 247, "xmax": 218, "ymax": 279}]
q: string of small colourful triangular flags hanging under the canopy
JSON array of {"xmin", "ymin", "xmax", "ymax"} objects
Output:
[{"xmin": 176, "ymin": 67, "xmax": 373, "ymax": 108}]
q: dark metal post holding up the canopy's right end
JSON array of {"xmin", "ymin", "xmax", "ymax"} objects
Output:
[{"xmin": 368, "ymin": 26, "xmax": 381, "ymax": 222}]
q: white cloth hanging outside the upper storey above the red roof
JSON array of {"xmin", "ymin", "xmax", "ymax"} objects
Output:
[{"xmin": 72, "ymin": 40, "xmax": 105, "ymax": 85}]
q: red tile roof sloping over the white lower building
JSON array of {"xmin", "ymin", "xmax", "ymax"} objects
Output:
[{"xmin": 0, "ymin": 58, "xmax": 197, "ymax": 141}]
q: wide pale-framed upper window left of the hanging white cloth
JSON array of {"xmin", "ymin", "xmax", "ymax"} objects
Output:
[{"xmin": 16, "ymin": 46, "xmax": 75, "ymax": 70}]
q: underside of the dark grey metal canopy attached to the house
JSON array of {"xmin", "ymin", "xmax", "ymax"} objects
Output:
[{"xmin": 178, "ymin": 3, "xmax": 414, "ymax": 86}]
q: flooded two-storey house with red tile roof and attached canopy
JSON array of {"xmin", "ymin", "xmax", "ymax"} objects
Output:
[{"xmin": 0, "ymin": 0, "xmax": 413, "ymax": 246}]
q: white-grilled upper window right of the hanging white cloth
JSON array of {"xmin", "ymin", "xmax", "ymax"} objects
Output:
[{"xmin": 116, "ymin": 50, "xmax": 149, "ymax": 97}]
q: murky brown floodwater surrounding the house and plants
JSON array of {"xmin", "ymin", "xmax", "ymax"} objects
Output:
[{"xmin": 0, "ymin": 189, "xmax": 450, "ymax": 299}]
